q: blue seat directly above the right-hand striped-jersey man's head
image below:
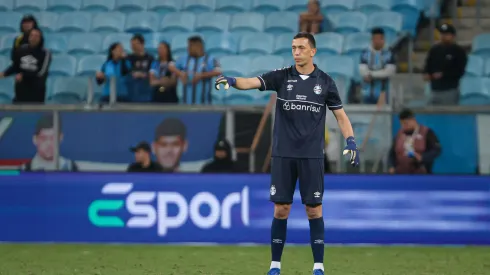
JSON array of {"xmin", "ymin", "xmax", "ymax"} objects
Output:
[{"xmin": 367, "ymin": 11, "xmax": 403, "ymax": 40}]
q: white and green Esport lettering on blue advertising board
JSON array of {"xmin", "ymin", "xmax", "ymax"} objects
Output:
[{"xmin": 88, "ymin": 182, "xmax": 250, "ymax": 237}]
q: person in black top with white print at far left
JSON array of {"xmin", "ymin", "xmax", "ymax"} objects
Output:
[{"xmin": 0, "ymin": 29, "xmax": 51, "ymax": 103}]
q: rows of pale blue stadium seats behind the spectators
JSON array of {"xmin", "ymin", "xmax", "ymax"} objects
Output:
[{"xmin": 0, "ymin": 0, "xmax": 484, "ymax": 104}]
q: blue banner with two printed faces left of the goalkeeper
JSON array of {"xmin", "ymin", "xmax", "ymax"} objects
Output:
[{"xmin": 0, "ymin": 112, "xmax": 223, "ymax": 172}]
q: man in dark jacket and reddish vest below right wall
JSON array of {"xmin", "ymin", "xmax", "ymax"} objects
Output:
[{"xmin": 388, "ymin": 109, "xmax": 441, "ymax": 174}]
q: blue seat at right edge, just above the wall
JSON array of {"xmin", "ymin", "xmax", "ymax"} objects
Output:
[{"xmin": 459, "ymin": 77, "xmax": 490, "ymax": 105}]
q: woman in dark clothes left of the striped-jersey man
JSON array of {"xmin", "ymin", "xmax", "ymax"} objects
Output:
[{"xmin": 150, "ymin": 42, "xmax": 179, "ymax": 103}]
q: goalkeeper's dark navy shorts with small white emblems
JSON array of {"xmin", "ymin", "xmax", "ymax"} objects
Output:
[{"xmin": 270, "ymin": 157, "xmax": 324, "ymax": 204}]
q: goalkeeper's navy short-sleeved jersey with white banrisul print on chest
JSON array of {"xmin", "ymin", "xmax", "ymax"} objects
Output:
[{"xmin": 257, "ymin": 65, "xmax": 342, "ymax": 158}]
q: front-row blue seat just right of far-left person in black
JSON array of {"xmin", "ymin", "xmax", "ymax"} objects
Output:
[{"xmin": 47, "ymin": 77, "xmax": 88, "ymax": 104}]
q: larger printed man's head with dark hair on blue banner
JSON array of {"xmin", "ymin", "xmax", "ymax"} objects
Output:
[{"xmin": 153, "ymin": 118, "xmax": 188, "ymax": 173}]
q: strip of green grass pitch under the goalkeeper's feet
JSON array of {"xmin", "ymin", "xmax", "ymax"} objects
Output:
[{"xmin": 0, "ymin": 244, "xmax": 490, "ymax": 275}]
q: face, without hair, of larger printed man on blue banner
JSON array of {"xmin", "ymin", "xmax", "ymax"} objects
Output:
[{"xmin": 153, "ymin": 136, "xmax": 187, "ymax": 170}]
